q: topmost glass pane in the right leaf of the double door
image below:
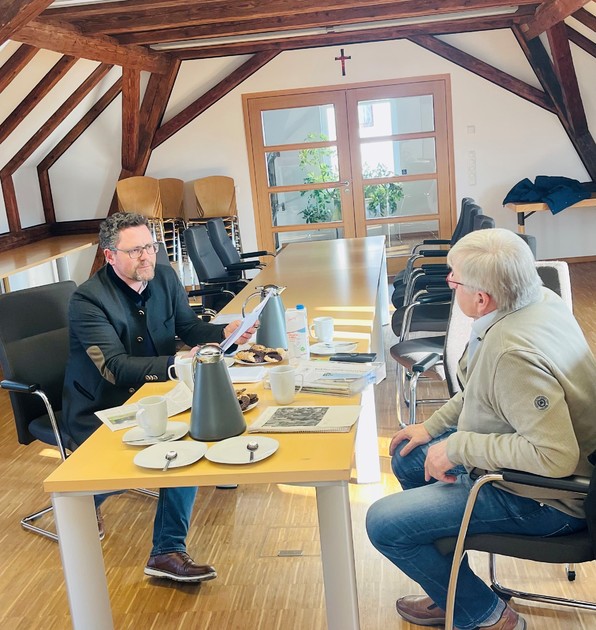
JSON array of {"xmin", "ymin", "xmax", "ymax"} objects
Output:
[{"xmin": 358, "ymin": 94, "xmax": 435, "ymax": 138}]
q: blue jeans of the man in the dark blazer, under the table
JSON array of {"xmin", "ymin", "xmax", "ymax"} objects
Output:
[{"xmin": 94, "ymin": 487, "xmax": 198, "ymax": 556}]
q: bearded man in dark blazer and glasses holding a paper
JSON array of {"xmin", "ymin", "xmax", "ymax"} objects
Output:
[{"xmin": 62, "ymin": 213, "xmax": 255, "ymax": 582}]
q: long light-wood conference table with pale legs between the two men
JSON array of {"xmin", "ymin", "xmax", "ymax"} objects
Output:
[{"xmin": 44, "ymin": 237, "xmax": 387, "ymax": 630}]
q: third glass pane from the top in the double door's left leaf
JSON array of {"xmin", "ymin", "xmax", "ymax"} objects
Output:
[{"xmin": 269, "ymin": 188, "xmax": 341, "ymax": 226}]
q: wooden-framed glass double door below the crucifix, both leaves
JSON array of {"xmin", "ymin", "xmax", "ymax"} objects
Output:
[{"xmin": 244, "ymin": 77, "xmax": 455, "ymax": 273}]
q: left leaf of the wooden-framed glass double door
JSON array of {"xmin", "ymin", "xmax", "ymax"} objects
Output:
[{"xmin": 248, "ymin": 92, "xmax": 355, "ymax": 249}]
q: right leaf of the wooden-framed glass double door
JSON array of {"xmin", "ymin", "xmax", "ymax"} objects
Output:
[{"xmin": 347, "ymin": 81, "xmax": 452, "ymax": 271}]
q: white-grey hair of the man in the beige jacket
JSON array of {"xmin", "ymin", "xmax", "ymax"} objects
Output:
[{"xmin": 447, "ymin": 228, "xmax": 542, "ymax": 311}]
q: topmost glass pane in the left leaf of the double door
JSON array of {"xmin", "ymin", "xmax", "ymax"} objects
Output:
[{"xmin": 261, "ymin": 104, "xmax": 337, "ymax": 146}]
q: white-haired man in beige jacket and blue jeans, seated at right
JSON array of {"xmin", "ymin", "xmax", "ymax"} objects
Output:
[{"xmin": 367, "ymin": 229, "xmax": 596, "ymax": 630}]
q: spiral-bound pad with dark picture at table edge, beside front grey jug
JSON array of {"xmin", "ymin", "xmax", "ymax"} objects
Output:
[{"xmin": 248, "ymin": 405, "xmax": 362, "ymax": 433}]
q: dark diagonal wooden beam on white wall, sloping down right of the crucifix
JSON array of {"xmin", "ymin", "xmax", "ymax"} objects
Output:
[{"xmin": 408, "ymin": 35, "xmax": 556, "ymax": 112}]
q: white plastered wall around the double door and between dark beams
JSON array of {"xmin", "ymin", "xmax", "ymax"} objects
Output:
[{"xmin": 0, "ymin": 31, "xmax": 596, "ymax": 280}]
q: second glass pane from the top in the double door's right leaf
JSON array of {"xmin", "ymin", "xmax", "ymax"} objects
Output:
[{"xmin": 360, "ymin": 138, "xmax": 436, "ymax": 179}]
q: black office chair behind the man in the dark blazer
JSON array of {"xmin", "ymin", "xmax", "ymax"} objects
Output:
[{"xmin": 0, "ymin": 281, "xmax": 76, "ymax": 540}]
